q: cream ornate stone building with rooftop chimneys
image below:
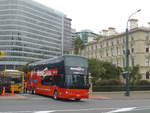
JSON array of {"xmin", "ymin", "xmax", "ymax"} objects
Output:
[{"xmin": 80, "ymin": 19, "xmax": 150, "ymax": 79}]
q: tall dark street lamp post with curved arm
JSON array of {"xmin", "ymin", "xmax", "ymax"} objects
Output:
[{"xmin": 125, "ymin": 9, "xmax": 141, "ymax": 96}]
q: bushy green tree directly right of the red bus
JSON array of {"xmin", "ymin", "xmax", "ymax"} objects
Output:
[{"xmin": 89, "ymin": 59, "xmax": 122, "ymax": 80}]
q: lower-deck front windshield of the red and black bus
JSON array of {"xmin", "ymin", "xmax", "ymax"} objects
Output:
[{"xmin": 66, "ymin": 75, "xmax": 89, "ymax": 89}]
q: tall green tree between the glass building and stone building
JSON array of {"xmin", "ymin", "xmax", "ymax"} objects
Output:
[{"xmin": 74, "ymin": 37, "xmax": 84, "ymax": 55}]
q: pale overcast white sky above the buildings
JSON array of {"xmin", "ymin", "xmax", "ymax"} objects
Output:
[{"xmin": 34, "ymin": 0, "xmax": 150, "ymax": 33}]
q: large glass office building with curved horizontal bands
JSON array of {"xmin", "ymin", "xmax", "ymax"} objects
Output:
[{"xmin": 0, "ymin": 0, "xmax": 71, "ymax": 70}]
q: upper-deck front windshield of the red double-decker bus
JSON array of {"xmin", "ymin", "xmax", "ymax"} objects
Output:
[{"xmin": 65, "ymin": 56, "xmax": 88, "ymax": 67}]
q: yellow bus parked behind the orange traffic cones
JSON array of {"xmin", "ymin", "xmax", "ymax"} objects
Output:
[{"xmin": 2, "ymin": 70, "xmax": 24, "ymax": 92}]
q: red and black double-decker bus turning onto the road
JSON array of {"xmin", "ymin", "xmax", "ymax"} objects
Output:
[{"xmin": 27, "ymin": 55, "xmax": 89, "ymax": 100}]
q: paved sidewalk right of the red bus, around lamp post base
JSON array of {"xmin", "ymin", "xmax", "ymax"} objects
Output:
[{"xmin": 90, "ymin": 91, "xmax": 150, "ymax": 100}]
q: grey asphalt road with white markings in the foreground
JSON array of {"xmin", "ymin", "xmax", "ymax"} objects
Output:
[{"xmin": 0, "ymin": 94, "xmax": 150, "ymax": 113}]
